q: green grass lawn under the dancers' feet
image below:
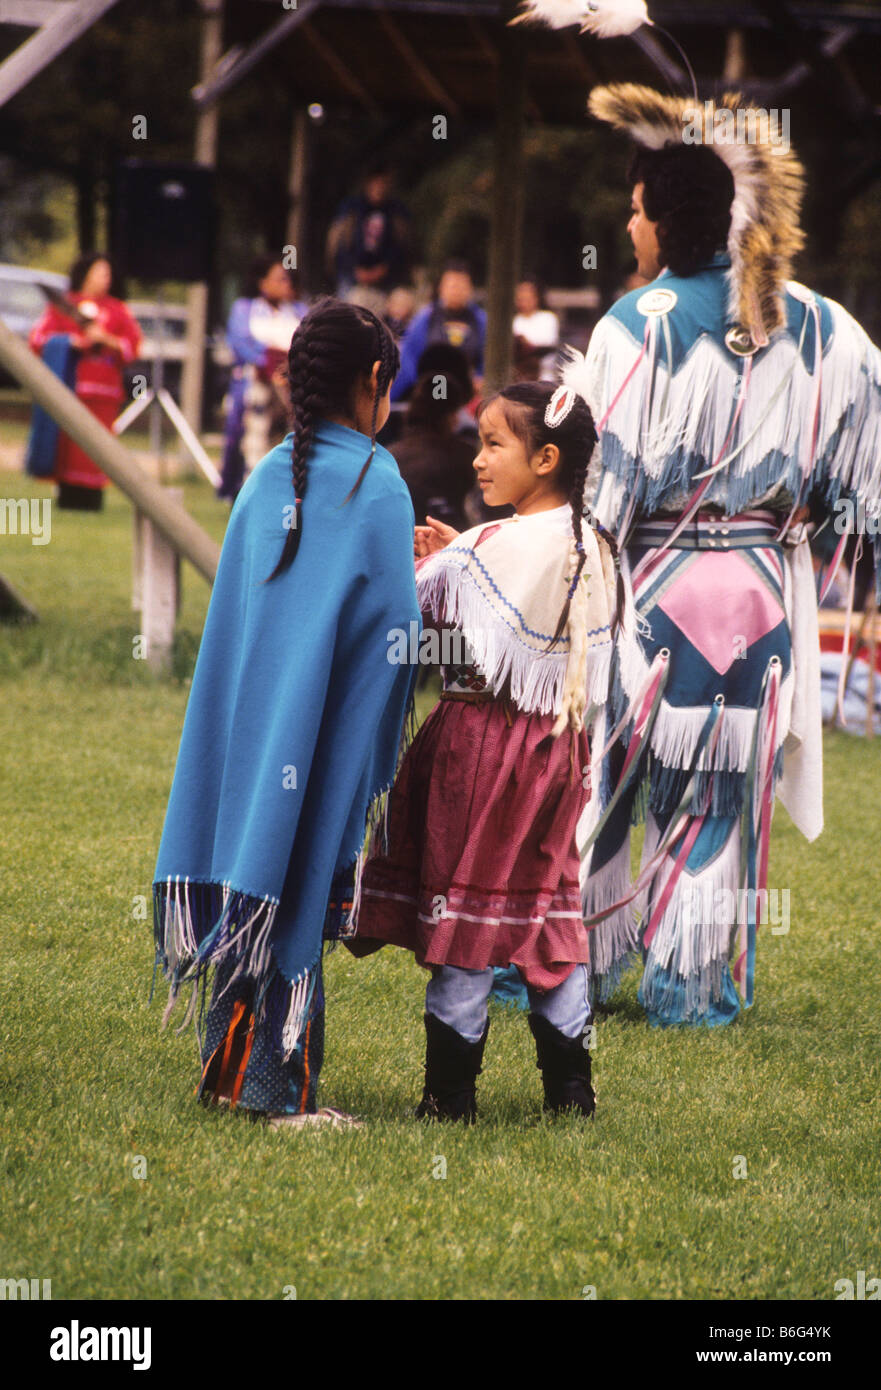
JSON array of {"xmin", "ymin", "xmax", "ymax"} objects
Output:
[{"xmin": 0, "ymin": 474, "xmax": 881, "ymax": 1300}]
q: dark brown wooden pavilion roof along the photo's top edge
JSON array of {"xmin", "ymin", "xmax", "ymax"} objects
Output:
[{"xmin": 213, "ymin": 0, "xmax": 881, "ymax": 124}]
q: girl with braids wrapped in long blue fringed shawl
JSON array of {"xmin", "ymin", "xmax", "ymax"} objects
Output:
[{"xmin": 154, "ymin": 299, "xmax": 418, "ymax": 1125}]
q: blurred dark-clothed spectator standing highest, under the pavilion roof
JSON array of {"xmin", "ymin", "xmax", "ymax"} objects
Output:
[{"xmin": 327, "ymin": 165, "xmax": 410, "ymax": 299}]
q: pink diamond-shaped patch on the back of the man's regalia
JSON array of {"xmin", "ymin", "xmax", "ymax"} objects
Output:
[{"xmin": 657, "ymin": 550, "xmax": 785, "ymax": 676}]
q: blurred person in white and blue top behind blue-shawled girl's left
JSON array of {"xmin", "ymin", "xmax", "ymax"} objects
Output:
[{"xmin": 217, "ymin": 256, "xmax": 307, "ymax": 500}]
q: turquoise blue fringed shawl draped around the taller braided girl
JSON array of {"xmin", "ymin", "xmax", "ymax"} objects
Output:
[{"xmin": 153, "ymin": 421, "xmax": 420, "ymax": 1055}]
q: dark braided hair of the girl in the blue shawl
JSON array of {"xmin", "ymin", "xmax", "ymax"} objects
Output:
[{"xmin": 270, "ymin": 296, "xmax": 400, "ymax": 580}]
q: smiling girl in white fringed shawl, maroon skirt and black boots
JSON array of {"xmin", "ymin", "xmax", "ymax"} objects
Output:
[{"xmin": 350, "ymin": 382, "xmax": 617, "ymax": 1122}]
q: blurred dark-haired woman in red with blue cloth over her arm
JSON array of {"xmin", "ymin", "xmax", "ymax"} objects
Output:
[{"xmin": 25, "ymin": 252, "xmax": 140, "ymax": 512}]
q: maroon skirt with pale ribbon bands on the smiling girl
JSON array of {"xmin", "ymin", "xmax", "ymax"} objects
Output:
[{"xmin": 350, "ymin": 699, "xmax": 589, "ymax": 990}]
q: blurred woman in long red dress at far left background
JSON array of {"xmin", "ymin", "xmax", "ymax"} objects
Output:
[{"xmin": 29, "ymin": 253, "xmax": 140, "ymax": 510}]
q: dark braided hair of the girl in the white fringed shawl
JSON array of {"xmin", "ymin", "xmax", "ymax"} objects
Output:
[{"xmin": 479, "ymin": 381, "xmax": 596, "ymax": 646}]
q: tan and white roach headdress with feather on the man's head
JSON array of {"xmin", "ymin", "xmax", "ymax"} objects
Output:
[{"xmin": 511, "ymin": 0, "xmax": 805, "ymax": 348}]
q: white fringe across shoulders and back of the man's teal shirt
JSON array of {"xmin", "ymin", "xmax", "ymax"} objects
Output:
[{"xmin": 563, "ymin": 290, "xmax": 881, "ymax": 553}]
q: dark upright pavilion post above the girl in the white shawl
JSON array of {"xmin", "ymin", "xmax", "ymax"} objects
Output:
[{"xmin": 484, "ymin": 0, "xmax": 527, "ymax": 391}]
